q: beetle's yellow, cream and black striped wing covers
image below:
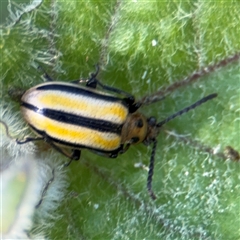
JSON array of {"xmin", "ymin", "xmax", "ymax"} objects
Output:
[{"xmin": 21, "ymin": 82, "xmax": 147, "ymax": 157}]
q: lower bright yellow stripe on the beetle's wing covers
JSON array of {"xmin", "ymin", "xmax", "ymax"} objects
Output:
[{"xmin": 23, "ymin": 108, "xmax": 121, "ymax": 151}]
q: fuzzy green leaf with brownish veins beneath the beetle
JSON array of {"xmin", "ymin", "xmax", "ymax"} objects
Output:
[{"xmin": 0, "ymin": 0, "xmax": 240, "ymax": 240}]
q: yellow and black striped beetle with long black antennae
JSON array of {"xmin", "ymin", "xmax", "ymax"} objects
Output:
[{"xmin": 9, "ymin": 68, "xmax": 217, "ymax": 199}]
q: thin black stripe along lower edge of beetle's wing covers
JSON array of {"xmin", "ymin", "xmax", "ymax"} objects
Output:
[{"xmin": 29, "ymin": 124, "xmax": 122, "ymax": 153}]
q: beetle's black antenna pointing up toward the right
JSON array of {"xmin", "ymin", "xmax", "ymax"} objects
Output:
[{"xmin": 156, "ymin": 93, "xmax": 217, "ymax": 128}]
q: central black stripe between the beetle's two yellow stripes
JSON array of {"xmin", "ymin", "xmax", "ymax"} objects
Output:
[{"xmin": 22, "ymin": 102, "xmax": 122, "ymax": 135}]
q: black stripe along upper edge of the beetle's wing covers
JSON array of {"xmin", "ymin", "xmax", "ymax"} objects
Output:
[{"xmin": 36, "ymin": 83, "xmax": 127, "ymax": 106}]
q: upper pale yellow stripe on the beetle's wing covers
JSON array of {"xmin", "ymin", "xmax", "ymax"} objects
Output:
[{"xmin": 37, "ymin": 91, "xmax": 128, "ymax": 124}]
